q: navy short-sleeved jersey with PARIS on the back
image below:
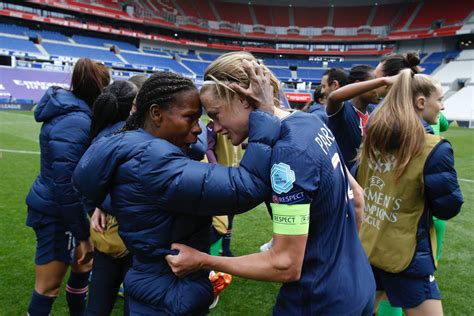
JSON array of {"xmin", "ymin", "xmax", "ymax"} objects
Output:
[{"xmin": 271, "ymin": 111, "xmax": 375, "ymax": 315}]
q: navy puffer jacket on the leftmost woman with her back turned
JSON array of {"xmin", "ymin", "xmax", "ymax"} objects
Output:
[{"xmin": 26, "ymin": 87, "xmax": 92, "ymax": 240}]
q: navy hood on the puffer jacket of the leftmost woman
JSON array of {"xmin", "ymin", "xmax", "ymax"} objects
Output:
[{"xmin": 35, "ymin": 87, "xmax": 92, "ymax": 122}]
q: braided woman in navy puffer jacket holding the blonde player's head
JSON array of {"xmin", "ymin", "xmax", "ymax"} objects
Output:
[{"xmin": 74, "ymin": 72, "xmax": 280, "ymax": 315}]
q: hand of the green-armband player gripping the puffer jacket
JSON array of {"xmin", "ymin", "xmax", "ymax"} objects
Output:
[{"xmin": 165, "ymin": 244, "xmax": 206, "ymax": 278}]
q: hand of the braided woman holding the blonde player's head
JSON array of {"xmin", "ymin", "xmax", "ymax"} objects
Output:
[{"xmin": 229, "ymin": 59, "xmax": 275, "ymax": 114}]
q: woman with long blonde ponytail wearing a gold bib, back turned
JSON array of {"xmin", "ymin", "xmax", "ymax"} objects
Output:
[{"xmin": 356, "ymin": 69, "xmax": 463, "ymax": 316}]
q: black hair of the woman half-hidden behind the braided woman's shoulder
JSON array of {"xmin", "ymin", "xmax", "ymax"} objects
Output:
[{"xmin": 89, "ymin": 81, "xmax": 138, "ymax": 139}]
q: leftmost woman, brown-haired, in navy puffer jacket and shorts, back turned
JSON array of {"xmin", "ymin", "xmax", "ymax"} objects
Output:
[{"xmin": 26, "ymin": 58, "xmax": 110, "ymax": 316}]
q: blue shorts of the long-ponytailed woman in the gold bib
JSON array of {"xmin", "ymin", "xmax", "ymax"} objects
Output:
[{"xmin": 372, "ymin": 266, "xmax": 441, "ymax": 308}]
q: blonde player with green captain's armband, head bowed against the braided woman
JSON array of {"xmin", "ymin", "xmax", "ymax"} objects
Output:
[{"xmin": 167, "ymin": 53, "xmax": 375, "ymax": 315}]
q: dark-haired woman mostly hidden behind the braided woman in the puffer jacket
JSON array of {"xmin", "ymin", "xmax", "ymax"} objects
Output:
[{"xmin": 85, "ymin": 81, "xmax": 138, "ymax": 315}]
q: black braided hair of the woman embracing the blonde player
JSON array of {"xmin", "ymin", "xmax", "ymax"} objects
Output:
[{"xmin": 122, "ymin": 71, "xmax": 196, "ymax": 131}]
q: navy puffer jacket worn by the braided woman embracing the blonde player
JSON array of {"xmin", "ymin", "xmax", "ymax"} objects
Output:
[{"xmin": 73, "ymin": 112, "xmax": 280, "ymax": 315}]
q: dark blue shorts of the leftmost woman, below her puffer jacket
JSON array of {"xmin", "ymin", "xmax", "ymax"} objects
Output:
[{"xmin": 27, "ymin": 209, "xmax": 76, "ymax": 265}]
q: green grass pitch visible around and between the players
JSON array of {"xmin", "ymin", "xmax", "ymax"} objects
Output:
[{"xmin": 0, "ymin": 111, "xmax": 474, "ymax": 315}]
